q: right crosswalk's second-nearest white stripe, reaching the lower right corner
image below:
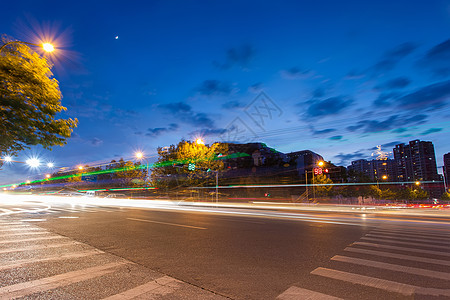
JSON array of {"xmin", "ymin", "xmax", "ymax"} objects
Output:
[{"xmin": 311, "ymin": 267, "xmax": 450, "ymax": 297}]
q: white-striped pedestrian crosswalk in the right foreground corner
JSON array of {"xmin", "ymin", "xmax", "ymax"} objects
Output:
[{"xmin": 277, "ymin": 225, "xmax": 450, "ymax": 299}]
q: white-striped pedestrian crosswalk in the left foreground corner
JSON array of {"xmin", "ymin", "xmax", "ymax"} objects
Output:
[{"xmin": 0, "ymin": 220, "xmax": 224, "ymax": 300}]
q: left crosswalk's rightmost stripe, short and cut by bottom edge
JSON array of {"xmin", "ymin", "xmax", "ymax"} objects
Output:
[{"xmin": 103, "ymin": 276, "xmax": 181, "ymax": 300}]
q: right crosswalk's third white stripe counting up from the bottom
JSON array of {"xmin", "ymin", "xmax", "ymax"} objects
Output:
[{"xmin": 331, "ymin": 255, "xmax": 450, "ymax": 280}]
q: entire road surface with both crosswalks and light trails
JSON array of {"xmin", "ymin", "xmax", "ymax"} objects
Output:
[{"xmin": 0, "ymin": 196, "xmax": 450, "ymax": 299}]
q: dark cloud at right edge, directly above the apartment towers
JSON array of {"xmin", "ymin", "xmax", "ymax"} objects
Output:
[{"xmin": 396, "ymin": 80, "xmax": 450, "ymax": 111}]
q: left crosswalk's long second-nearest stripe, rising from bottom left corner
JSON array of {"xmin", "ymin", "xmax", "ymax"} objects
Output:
[{"xmin": 0, "ymin": 261, "xmax": 129, "ymax": 299}]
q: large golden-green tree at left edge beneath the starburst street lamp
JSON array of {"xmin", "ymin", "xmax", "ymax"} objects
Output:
[{"xmin": 0, "ymin": 39, "xmax": 78, "ymax": 159}]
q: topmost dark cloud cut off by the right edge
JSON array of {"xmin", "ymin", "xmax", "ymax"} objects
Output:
[{"xmin": 419, "ymin": 39, "xmax": 450, "ymax": 78}]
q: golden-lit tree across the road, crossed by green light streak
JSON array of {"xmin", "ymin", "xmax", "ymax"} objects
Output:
[{"xmin": 151, "ymin": 140, "xmax": 228, "ymax": 187}]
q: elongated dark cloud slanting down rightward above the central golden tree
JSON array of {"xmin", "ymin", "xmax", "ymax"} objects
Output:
[{"xmin": 159, "ymin": 102, "xmax": 214, "ymax": 128}]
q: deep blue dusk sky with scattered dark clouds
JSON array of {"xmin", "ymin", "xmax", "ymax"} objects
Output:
[{"xmin": 0, "ymin": 0, "xmax": 450, "ymax": 183}]
